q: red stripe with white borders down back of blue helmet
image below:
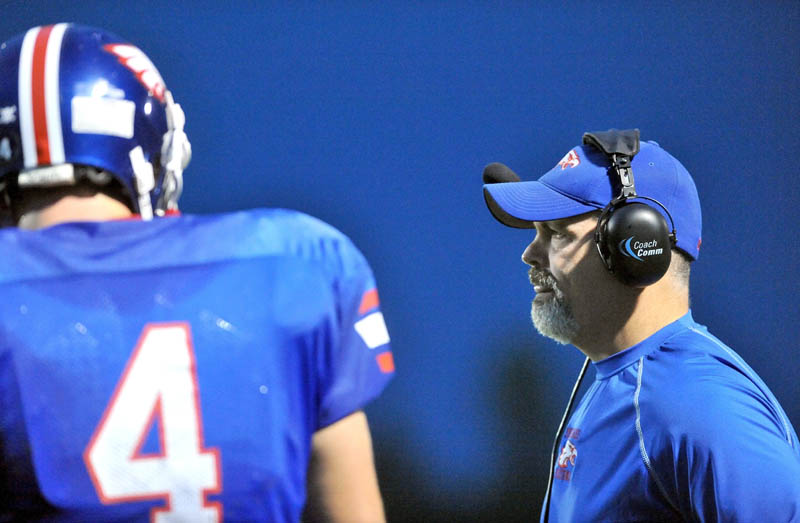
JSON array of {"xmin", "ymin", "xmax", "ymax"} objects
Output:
[{"xmin": 18, "ymin": 24, "xmax": 67, "ymax": 168}]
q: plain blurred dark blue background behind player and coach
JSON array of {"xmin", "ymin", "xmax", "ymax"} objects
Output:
[{"xmin": 0, "ymin": 0, "xmax": 800, "ymax": 520}]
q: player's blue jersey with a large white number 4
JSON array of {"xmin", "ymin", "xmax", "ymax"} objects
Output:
[{"xmin": 0, "ymin": 210, "xmax": 394, "ymax": 521}]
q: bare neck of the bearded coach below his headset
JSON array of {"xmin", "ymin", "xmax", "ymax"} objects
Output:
[{"xmin": 575, "ymin": 278, "xmax": 689, "ymax": 361}]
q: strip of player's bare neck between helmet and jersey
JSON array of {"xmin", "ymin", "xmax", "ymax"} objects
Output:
[{"xmin": 18, "ymin": 193, "xmax": 133, "ymax": 229}]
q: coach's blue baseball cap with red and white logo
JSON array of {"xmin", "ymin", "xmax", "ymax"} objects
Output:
[{"xmin": 483, "ymin": 141, "xmax": 702, "ymax": 260}]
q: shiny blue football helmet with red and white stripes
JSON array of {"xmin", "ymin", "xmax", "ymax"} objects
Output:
[{"xmin": 0, "ymin": 24, "xmax": 191, "ymax": 219}]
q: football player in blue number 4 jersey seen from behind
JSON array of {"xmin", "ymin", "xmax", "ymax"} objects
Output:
[{"xmin": 0, "ymin": 24, "xmax": 394, "ymax": 522}]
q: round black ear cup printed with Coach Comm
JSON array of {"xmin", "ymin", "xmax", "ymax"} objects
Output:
[{"xmin": 597, "ymin": 201, "xmax": 672, "ymax": 287}]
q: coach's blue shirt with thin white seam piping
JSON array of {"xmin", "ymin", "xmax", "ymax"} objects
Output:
[{"xmin": 542, "ymin": 313, "xmax": 800, "ymax": 522}]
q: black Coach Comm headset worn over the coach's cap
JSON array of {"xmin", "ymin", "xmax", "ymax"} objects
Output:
[{"xmin": 583, "ymin": 129, "xmax": 676, "ymax": 287}]
